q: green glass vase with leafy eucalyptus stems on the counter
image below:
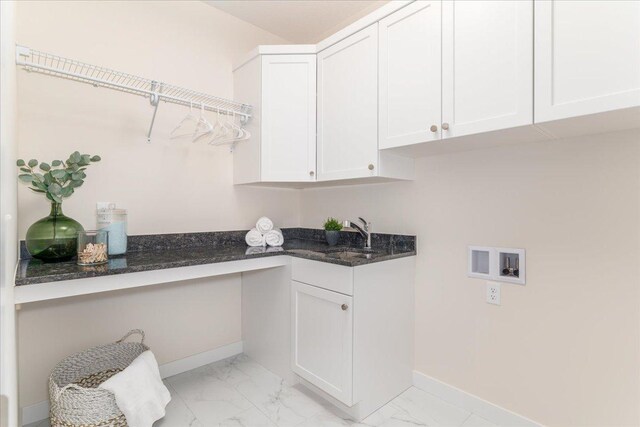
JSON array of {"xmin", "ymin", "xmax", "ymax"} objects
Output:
[{"xmin": 16, "ymin": 151, "xmax": 100, "ymax": 262}]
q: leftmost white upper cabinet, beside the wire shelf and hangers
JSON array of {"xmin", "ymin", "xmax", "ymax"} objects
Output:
[{"xmin": 234, "ymin": 54, "xmax": 316, "ymax": 184}]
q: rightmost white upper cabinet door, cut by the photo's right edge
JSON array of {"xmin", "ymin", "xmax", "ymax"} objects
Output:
[{"xmin": 535, "ymin": 0, "xmax": 640, "ymax": 123}]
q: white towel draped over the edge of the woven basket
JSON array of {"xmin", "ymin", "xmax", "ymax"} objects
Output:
[{"xmin": 100, "ymin": 350, "xmax": 171, "ymax": 427}]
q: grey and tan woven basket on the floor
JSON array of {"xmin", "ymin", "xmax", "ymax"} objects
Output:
[{"xmin": 49, "ymin": 329, "xmax": 149, "ymax": 427}]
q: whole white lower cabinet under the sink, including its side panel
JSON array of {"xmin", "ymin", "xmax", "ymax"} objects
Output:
[{"xmin": 291, "ymin": 257, "xmax": 415, "ymax": 420}]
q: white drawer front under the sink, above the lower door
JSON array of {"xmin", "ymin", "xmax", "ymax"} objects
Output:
[{"xmin": 291, "ymin": 258, "xmax": 353, "ymax": 295}]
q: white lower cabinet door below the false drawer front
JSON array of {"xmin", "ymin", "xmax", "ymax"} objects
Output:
[{"xmin": 291, "ymin": 281, "xmax": 353, "ymax": 406}]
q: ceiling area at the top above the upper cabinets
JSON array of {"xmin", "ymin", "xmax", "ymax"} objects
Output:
[{"xmin": 205, "ymin": 0, "xmax": 388, "ymax": 44}]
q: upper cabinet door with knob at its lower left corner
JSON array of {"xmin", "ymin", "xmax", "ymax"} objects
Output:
[{"xmin": 442, "ymin": 0, "xmax": 533, "ymax": 138}]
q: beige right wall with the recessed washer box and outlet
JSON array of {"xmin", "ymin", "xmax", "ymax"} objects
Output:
[{"xmin": 301, "ymin": 133, "xmax": 640, "ymax": 426}]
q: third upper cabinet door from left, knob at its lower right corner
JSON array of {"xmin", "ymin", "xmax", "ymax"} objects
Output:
[{"xmin": 379, "ymin": 0, "xmax": 442, "ymax": 149}]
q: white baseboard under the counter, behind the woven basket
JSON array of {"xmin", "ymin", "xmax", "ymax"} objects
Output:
[{"xmin": 22, "ymin": 341, "xmax": 243, "ymax": 426}]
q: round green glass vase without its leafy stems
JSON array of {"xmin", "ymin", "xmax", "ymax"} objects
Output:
[{"xmin": 26, "ymin": 203, "xmax": 84, "ymax": 262}]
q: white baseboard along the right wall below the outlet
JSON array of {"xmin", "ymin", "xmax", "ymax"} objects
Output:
[{"xmin": 413, "ymin": 371, "xmax": 542, "ymax": 427}]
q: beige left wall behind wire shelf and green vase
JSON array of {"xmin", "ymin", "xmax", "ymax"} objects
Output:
[{"xmin": 17, "ymin": 1, "xmax": 300, "ymax": 406}]
